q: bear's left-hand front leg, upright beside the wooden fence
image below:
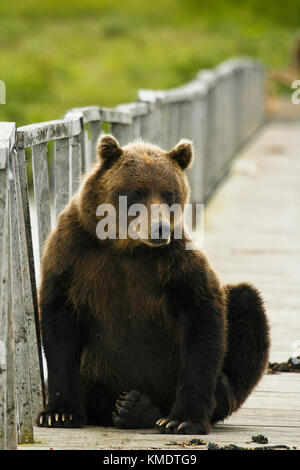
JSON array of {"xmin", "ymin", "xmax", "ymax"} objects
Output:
[{"xmin": 36, "ymin": 277, "xmax": 85, "ymax": 428}]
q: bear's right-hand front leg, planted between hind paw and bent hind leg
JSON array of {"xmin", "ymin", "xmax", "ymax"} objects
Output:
[{"xmin": 156, "ymin": 255, "xmax": 226, "ymax": 434}]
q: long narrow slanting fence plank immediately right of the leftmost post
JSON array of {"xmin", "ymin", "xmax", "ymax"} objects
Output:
[{"xmin": 9, "ymin": 152, "xmax": 33, "ymax": 443}]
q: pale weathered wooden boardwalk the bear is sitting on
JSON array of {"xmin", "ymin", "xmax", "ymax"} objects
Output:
[{"xmin": 20, "ymin": 123, "xmax": 300, "ymax": 450}]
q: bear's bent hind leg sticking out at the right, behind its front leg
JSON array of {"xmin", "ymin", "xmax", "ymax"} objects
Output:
[{"xmin": 211, "ymin": 283, "xmax": 270, "ymax": 423}]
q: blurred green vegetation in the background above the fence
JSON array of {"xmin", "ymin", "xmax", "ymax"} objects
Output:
[{"xmin": 0, "ymin": 0, "xmax": 300, "ymax": 125}]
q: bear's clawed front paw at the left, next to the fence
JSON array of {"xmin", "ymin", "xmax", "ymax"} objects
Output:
[{"xmin": 36, "ymin": 410, "xmax": 85, "ymax": 428}]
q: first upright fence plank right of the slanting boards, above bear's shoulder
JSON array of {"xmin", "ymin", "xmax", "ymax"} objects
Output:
[{"xmin": 32, "ymin": 143, "xmax": 51, "ymax": 257}]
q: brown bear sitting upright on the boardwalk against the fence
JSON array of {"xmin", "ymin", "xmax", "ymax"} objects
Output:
[{"xmin": 37, "ymin": 135, "xmax": 269, "ymax": 434}]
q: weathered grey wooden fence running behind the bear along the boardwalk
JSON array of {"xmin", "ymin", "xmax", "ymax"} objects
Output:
[{"xmin": 0, "ymin": 59, "xmax": 264, "ymax": 449}]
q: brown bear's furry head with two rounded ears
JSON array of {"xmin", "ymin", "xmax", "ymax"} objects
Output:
[{"xmin": 78, "ymin": 135, "xmax": 193, "ymax": 248}]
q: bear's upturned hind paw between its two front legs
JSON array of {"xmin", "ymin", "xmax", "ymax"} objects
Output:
[{"xmin": 112, "ymin": 390, "xmax": 161, "ymax": 429}]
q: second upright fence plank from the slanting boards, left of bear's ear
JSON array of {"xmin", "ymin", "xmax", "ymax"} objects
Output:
[{"xmin": 54, "ymin": 138, "xmax": 70, "ymax": 219}]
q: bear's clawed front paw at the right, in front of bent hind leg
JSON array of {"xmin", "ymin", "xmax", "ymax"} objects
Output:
[{"xmin": 156, "ymin": 418, "xmax": 210, "ymax": 434}]
